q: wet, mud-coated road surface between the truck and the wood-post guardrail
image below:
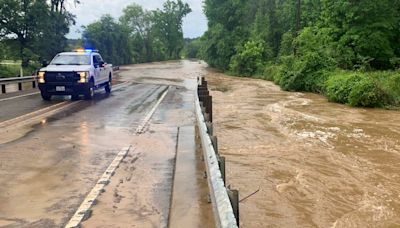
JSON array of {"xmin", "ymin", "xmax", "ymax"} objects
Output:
[{"xmin": 0, "ymin": 61, "xmax": 213, "ymax": 228}]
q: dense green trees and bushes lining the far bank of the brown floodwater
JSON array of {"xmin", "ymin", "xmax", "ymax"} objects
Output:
[{"xmin": 200, "ymin": 0, "xmax": 400, "ymax": 107}]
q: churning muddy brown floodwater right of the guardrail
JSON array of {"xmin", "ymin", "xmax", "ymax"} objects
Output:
[{"xmin": 204, "ymin": 70, "xmax": 400, "ymax": 228}]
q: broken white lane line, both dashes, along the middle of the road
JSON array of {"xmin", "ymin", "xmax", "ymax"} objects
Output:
[{"xmin": 65, "ymin": 84, "xmax": 169, "ymax": 228}]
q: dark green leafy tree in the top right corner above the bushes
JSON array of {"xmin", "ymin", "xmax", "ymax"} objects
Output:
[{"xmin": 319, "ymin": 0, "xmax": 399, "ymax": 69}]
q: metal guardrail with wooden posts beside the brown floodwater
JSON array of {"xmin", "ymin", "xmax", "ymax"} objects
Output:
[{"xmin": 195, "ymin": 78, "xmax": 239, "ymax": 228}]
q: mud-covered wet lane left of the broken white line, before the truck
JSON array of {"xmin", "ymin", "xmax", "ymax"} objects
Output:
[{"xmin": 0, "ymin": 85, "xmax": 169, "ymax": 227}]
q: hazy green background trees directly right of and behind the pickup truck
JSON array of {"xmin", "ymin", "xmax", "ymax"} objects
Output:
[{"xmin": 82, "ymin": 0, "xmax": 191, "ymax": 65}]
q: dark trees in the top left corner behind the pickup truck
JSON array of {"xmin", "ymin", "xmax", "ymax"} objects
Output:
[{"xmin": 0, "ymin": 0, "xmax": 75, "ymax": 67}]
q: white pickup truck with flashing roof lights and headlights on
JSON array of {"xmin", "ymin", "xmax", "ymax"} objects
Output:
[{"xmin": 37, "ymin": 49, "xmax": 113, "ymax": 101}]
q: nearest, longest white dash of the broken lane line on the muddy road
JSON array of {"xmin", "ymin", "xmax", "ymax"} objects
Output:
[{"xmin": 65, "ymin": 146, "xmax": 132, "ymax": 228}]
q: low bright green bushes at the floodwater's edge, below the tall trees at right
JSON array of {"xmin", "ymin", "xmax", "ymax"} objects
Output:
[{"xmin": 255, "ymin": 65, "xmax": 400, "ymax": 109}]
